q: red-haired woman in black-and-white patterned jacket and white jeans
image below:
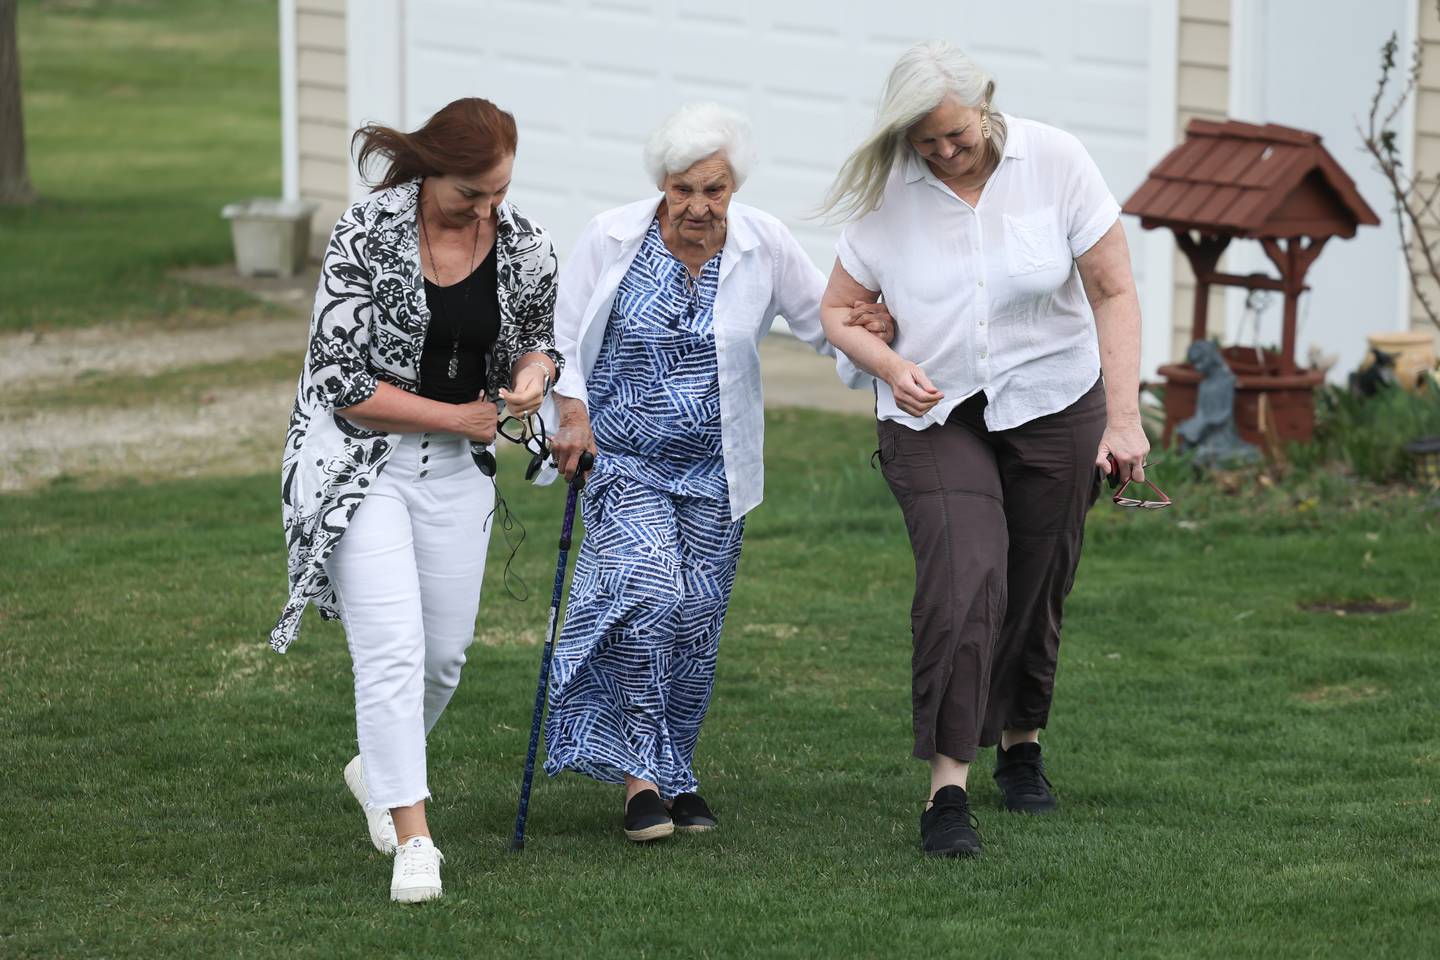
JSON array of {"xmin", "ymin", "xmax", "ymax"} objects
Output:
[{"xmin": 271, "ymin": 98, "xmax": 562, "ymax": 901}]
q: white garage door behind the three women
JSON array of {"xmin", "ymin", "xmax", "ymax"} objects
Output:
[{"xmin": 348, "ymin": 0, "xmax": 1176, "ymax": 368}]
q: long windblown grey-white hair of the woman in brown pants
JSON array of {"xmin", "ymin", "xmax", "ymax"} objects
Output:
[{"xmin": 819, "ymin": 40, "xmax": 1005, "ymax": 220}]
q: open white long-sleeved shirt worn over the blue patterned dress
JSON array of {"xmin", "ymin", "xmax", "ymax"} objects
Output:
[{"xmin": 554, "ymin": 197, "xmax": 870, "ymax": 520}]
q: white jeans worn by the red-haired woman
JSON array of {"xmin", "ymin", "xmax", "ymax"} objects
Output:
[{"xmin": 325, "ymin": 433, "xmax": 495, "ymax": 809}]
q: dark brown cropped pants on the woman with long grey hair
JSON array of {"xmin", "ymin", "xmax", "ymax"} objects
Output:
[{"xmin": 878, "ymin": 383, "xmax": 1104, "ymax": 763}]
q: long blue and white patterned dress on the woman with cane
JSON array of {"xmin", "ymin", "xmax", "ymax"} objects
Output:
[{"xmin": 546, "ymin": 220, "xmax": 744, "ymax": 799}]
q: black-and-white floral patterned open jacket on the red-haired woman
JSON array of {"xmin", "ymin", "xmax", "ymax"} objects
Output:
[{"xmin": 269, "ymin": 180, "xmax": 563, "ymax": 653}]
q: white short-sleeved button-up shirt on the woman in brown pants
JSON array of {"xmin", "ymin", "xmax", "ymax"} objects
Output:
[{"xmin": 840, "ymin": 115, "xmax": 1120, "ymax": 430}]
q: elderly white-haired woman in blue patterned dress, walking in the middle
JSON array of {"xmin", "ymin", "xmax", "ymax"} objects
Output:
[{"xmin": 546, "ymin": 104, "xmax": 891, "ymax": 842}]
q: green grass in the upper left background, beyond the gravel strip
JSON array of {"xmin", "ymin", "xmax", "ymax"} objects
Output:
[{"xmin": 0, "ymin": 0, "xmax": 281, "ymax": 331}]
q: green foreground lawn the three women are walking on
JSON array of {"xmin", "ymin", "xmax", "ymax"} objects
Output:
[{"xmin": 0, "ymin": 412, "xmax": 1440, "ymax": 957}]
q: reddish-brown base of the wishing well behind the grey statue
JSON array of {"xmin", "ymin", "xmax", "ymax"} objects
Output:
[{"xmin": 1159, "ymin": 347, "xmax": 1325, "ymax": 450}]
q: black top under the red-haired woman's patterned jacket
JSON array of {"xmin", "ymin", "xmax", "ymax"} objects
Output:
[{"xmin": 419, "ymin": 246, "xmax": 500, "ymax": 403}]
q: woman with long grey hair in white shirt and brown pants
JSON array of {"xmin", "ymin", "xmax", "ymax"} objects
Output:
[{"xmin": 821, "ymin": 42, "xmax": 1149, "ymax": 856}]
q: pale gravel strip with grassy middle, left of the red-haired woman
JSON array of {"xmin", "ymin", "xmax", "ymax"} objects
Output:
[{"xmin": 0, "ymin": 307, "xmax": 307, "ymax": 491}]
